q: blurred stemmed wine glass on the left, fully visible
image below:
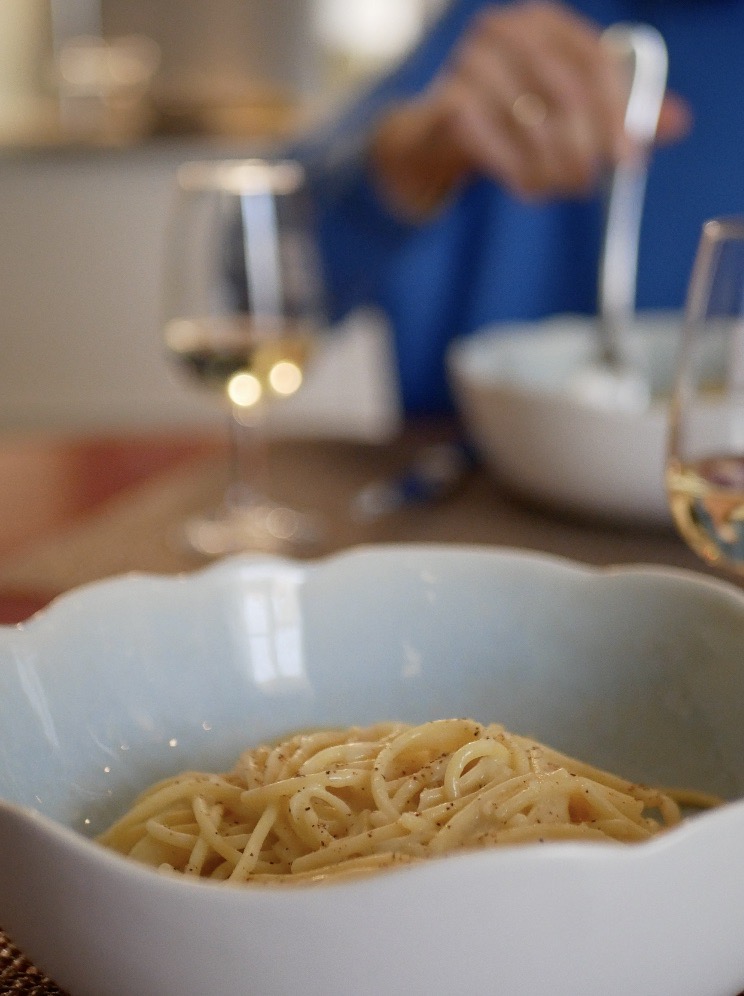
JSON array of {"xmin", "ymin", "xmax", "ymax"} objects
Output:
[{"xmin": 164, "ymin": 159, "xmax": 326, "ymax": 557}]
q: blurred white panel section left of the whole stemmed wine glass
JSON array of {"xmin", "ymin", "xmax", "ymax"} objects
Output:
[{"xmin": 0, "ymin": 148, "xmax": 230, "ymax": 425}]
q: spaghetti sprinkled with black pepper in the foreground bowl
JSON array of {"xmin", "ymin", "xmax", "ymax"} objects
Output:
[{"xmin": 99, "ymin": 719, "xmax": 717, "ymax": 882}]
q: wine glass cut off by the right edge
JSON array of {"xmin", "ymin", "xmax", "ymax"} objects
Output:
[{"xmin": 666, "ymin": 217, "xmax": 744, "ymax": 574}]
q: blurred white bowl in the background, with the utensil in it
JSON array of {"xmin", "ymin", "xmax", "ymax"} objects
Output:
[{"xmin": 448, "ymin": 312, "xmax": 681, "ymax": 525}]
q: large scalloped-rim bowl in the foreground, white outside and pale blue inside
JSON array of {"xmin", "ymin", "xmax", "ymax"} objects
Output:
[{"xmin": 0, "ymin": 545, "xmax": 744, "ymax": 996}]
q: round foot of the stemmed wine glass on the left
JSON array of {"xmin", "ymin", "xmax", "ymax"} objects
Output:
[{"xmin": 180, "ymin": 501, "xmax": 324, "ymax": 557}]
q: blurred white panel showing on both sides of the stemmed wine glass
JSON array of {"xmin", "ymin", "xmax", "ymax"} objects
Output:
[{"xmin": 0, "ymin": 141, "xmax": 398, "ymax": 438}]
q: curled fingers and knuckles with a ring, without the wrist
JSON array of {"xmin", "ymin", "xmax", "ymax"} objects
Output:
[{"xmin": 432, "ymin": 2, "xmax": 656, "ymax": 198}]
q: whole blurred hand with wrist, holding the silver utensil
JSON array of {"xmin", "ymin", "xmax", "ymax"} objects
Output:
[{"xmin": 371, "ymin": 0, "xmax": 690, "ymax": 218}]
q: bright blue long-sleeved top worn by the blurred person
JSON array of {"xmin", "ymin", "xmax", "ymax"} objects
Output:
[{"xmin": 300, "ymin": 0, "xmax": 744, "ymax": 413}]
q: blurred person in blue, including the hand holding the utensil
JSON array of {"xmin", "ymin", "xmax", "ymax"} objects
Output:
[{"xmin": 293, "ymin": 0, "xmax": 744, "ymax": 413}]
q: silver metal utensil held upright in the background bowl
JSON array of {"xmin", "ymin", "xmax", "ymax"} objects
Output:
[{"xmin": 569, "ymin": 24, "xmax": 667, "ymax": 411}]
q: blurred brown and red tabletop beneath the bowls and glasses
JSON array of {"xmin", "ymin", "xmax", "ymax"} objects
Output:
[{"xmin": 0, "ymin": 422, "xmax": 736, "ymax": 994}]
